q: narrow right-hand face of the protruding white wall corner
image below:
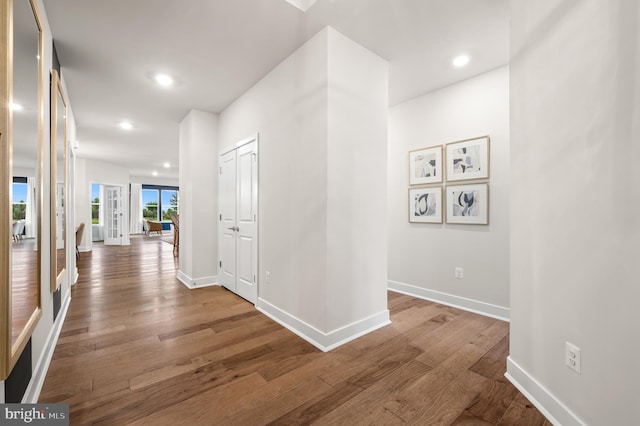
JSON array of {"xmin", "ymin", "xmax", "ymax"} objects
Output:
[{"xmin": 326, "ymin": 30, "xmax": 389, "ymax": 331}]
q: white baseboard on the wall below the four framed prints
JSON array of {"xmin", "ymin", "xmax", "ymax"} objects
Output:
[{"xmin": 387, "ymin": 280, "xmax": 511, "ymax": 322}]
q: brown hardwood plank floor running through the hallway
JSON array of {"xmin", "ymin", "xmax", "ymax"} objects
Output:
[{"xmin": 40, "ymin": 237, "xmax": 550, "ymax": 425}]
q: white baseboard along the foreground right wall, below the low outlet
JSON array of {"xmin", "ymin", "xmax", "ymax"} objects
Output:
[{"xmin": 504, "ymin": 356, "xmax": 586, "ymax": 426}]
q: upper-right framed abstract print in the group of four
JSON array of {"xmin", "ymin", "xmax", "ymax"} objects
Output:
[{"xmin": 445, "ymin": 136, "xmax": 489, "ymax": 182}]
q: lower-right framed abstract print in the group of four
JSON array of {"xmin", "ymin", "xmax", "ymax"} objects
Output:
[{"xmin": 446, "ymin": 183, "xmax": 489, "ymax": 225}]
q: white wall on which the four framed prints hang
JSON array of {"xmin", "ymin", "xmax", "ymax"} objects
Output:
[{"xmin": 388, "ymin": 67, "xmax": 509, "ymax": 318}]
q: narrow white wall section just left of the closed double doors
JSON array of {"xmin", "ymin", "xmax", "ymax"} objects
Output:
[{"xmin": 178, "ymin": 110, "xmax": 218, "ymax": 287}]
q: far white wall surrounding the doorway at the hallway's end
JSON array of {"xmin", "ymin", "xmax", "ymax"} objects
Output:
[{"xmin": 75, "ymin": 157, "xmax": 129, "ymax": 251}]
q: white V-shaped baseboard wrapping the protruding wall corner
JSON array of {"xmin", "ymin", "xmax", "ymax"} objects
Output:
[{"xmin": 256, "ymin": 299, "xmax": 391, "ymax": 352}]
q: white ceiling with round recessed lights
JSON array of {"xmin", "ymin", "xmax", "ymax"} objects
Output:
[{"xmin": 44, "ymin": 0, "xmax": 509, "ymax": 179}]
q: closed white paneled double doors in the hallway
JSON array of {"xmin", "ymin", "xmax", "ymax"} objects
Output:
[{"xmin": 218, "ymin": 137, "xmax": 258, "ymax": 304}]
